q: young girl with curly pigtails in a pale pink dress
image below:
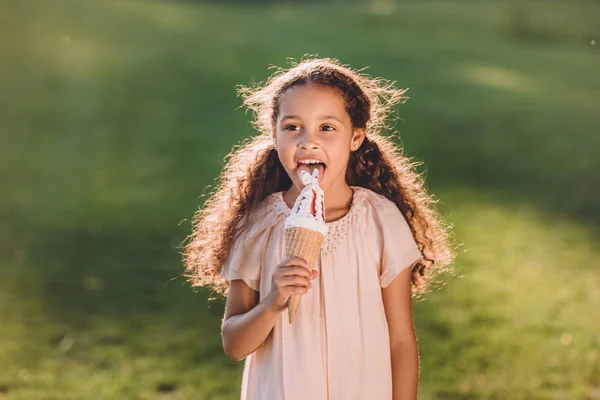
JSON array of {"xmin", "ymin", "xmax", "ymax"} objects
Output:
[{"xmin": 184, "ymin": 59, "xmax": 454, "ymax": 400}]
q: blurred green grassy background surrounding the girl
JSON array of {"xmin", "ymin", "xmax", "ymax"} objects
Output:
[{"xmin": 0, "ymin": 0, "xmax": 600, "ymax": 400}]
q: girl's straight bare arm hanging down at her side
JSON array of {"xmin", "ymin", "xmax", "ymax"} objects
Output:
[{"xmin": 382, "ymin": 268, "xmax": 419, "ymax": 400}]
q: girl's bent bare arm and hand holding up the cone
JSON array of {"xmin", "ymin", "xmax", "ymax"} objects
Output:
[{"xmin": 221, "ymin": 257, "xmax": 318, "ymax": 361}]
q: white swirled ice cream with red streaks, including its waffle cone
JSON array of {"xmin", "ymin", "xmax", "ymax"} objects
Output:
[{"xmin": 285, "ymin": 168, "xmax": 327, "ymax": 323}]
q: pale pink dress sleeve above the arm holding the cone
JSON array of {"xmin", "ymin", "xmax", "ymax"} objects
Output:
[{"xmin": 221, "ymin": 214, "xmax": 270, "ymax": 292}]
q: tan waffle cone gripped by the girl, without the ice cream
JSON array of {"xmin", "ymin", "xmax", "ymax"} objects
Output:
[{"xmin": 285, "ymin": 228, "xmax": 325, "ymax": 324}]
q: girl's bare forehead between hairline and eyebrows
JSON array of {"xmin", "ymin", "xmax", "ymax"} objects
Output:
[{"xmin": 279, "ymin": 84, "xmax": 349, "ymax": 120}]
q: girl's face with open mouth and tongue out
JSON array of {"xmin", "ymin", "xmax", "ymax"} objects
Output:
[{"xmin": 273, "ymin": 84, "xmax": 365, "ymax": 192}]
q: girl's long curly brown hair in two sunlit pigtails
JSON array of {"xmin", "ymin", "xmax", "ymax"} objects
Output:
[{"xmin": 183, "ymin": 58, "xmax": 455, "ymax": 295}]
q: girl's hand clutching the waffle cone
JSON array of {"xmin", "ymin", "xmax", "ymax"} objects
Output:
[{"xmin": 265, "ymin": 257, "xmax": 319, "ymax": 312}]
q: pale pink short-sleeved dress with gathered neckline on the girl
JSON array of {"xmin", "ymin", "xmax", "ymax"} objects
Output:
[{"xmin": 222, "ymin": 186, "xmax": 422, "ymax": 400}]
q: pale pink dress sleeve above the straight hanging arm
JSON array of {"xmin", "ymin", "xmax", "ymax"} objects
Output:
[{"xmin": 376, "ymin": 196, "xmax": 423, "ymax": 288}]
